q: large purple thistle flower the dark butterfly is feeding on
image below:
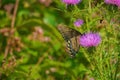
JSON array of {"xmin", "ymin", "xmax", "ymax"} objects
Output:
[{"xmin": 79, "ymin": 32, "xmax": 101, "ymax": 47}]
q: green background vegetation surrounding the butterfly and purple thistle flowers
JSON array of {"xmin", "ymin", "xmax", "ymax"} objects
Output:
[{"xmin": 0, "ymin": 0, "xmax": 120, "ymax": 80}]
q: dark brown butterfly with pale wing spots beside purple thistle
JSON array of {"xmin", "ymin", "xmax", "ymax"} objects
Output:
[{"xmin": 57, "ymin": 24, "xmax": 82, "ymax": 57}]
